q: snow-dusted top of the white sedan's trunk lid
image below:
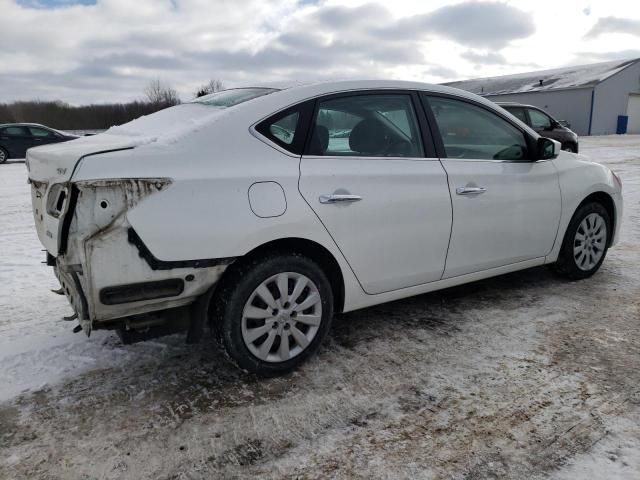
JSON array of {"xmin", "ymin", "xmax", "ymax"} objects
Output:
[{"xmin": 27, "ymin": 103, "xmax": 228, "ymax": 183}]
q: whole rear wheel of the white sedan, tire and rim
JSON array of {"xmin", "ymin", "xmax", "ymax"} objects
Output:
[{"xmin": 215, "ymin": 253, "xmax": 333, "ymax": 377}]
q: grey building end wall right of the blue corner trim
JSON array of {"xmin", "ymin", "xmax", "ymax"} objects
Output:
[{"xmin": 591, "ymin": 62, "xmax": 640, "ymax": 135}]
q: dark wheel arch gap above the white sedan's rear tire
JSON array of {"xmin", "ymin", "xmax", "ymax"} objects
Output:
[{"xmin": 221, "ymin": 238, "xmax": 344, "ymax": 313}]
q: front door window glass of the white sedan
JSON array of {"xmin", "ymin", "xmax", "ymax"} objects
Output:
[{"xmin": 426, "ymin": 96, "xmax": 527, "ymax": 160}]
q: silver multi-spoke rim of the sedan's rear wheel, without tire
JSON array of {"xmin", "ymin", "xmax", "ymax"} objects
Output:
[{"xmin": 242, "ymin": 272, "xmax": 322, "ymax": 363}]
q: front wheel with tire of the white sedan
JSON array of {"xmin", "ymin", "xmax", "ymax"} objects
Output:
[{"xmin": 553, "ymin": 202, "xmax": 612, "ymax": 280}]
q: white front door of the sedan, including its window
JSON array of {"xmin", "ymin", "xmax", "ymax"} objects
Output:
[{"xmin": 423, "ymin": 95, "xmax": 561, "ymax": 278}]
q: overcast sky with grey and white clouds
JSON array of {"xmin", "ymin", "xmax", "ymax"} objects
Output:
[{"xmin": 0, "ymin": 0, "xmax": 640, "ymax": 104}]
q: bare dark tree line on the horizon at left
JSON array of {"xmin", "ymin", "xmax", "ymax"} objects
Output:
[{"xmin": 0, "ymin": 80, "xmax": 224, "ymax": 130}]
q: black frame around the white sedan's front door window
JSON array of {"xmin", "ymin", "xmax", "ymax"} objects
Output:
[{"xmin": 419, "ymin": 90, "xmax": 542, "ymax": 163}]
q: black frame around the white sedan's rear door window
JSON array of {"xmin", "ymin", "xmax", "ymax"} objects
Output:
[{"xmin": 303, "ymin": 88, "xmax": 438, "ymax": 160}]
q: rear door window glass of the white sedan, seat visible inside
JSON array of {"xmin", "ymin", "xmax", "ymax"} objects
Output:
[{"xmin": 308, "ymin": 94, "xmax": 424, "ymax": 157}]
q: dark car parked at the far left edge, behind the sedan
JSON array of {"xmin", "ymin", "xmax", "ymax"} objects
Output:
[{"xmin": 0, "ymin": 123, "xmax": 78, "ymax": 163}]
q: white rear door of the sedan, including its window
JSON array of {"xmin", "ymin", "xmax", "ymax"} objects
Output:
[{"xmin": 299, "ymin": 91, "xmax": 452, "ymax": 294}]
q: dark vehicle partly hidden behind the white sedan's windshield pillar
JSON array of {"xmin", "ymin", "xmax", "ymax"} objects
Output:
[{"xmin": 496, "ymin": 102, "xmax": 578, "ymax": 153}]
